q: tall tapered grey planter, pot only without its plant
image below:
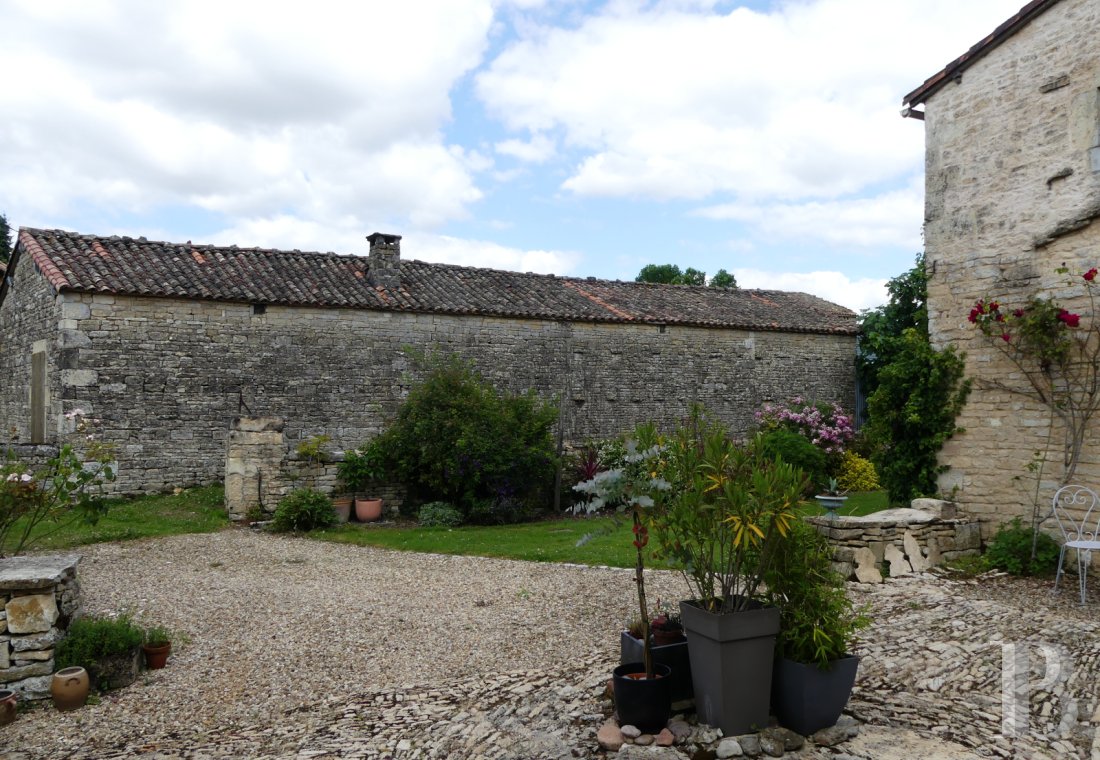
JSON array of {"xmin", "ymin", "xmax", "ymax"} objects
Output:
[{"xmin": 680, "ymin": 602, "xmax": 779, "ymax": 736}]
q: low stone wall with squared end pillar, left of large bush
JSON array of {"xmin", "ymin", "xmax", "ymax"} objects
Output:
[{"xmin": 226, "ymin": 417, "xmax": 405, "ymax": 520}]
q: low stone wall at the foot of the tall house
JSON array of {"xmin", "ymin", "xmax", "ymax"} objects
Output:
[{"xmin": 809, "ymin": 499, "xmax": 981, "ymax": 583}]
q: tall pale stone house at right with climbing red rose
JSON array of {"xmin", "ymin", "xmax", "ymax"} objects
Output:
[{"xmin": 902, "ymin": 0, "xmax": 1100, "ymax": 530}]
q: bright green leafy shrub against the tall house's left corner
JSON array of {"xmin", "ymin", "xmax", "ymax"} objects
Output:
[{"xmin": 867, "ymin": 328, "xmax": 970, "ymax": 504}]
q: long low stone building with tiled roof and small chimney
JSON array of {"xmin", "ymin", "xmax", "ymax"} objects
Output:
[{"xmin": 0, "ymin": 229, "xmax": 857, "ymax": 493}]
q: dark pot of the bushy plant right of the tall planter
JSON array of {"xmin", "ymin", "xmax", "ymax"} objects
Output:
[{"xmin": 771, "ymin": 654, "xmax": 859, "ymax": 736}]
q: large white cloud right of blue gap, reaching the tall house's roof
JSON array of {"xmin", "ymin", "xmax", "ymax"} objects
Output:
[{"xmin": 477, "ymin": 0, "xmax": 1019, "ymax": 202}]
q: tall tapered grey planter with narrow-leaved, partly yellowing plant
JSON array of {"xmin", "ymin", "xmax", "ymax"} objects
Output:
[{"xmin": 651, "ymin": 407, "xmax": 805, "ymax": 736}]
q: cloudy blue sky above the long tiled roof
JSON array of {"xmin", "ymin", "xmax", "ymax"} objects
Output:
[{"xmin": 0, "ymin": 0, "xmax": 1024, "ymax": 310}]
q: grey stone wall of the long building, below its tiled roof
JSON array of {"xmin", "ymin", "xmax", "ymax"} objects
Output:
[{"xmin": 0, "ymin": 285, "xmax": 855, "ymax": 493}]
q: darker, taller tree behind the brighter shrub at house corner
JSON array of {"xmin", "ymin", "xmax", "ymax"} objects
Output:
[{"xmin": 856, "ymin": 253, "xmax": 928, "ymax": 396}]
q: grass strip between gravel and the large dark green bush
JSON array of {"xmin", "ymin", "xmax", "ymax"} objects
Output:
[{"xmin": 309, "ymin": 491, "xmax": 888, "ymax": 568}]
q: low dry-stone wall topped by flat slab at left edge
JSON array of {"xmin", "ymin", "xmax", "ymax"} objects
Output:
[{"xmin": 0, "ymin": 554, "xmax": 80, "ymax": 700}]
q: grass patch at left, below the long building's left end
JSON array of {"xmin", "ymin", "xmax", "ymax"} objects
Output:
[{"xmin": 3, "ymin": 486, "xmax": 229, "ymax": 551}]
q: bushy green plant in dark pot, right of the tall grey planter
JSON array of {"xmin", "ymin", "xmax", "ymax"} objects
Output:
[{"xmin": 768, "ymin": 521, "xmax": 870, "ymax": 736}]
